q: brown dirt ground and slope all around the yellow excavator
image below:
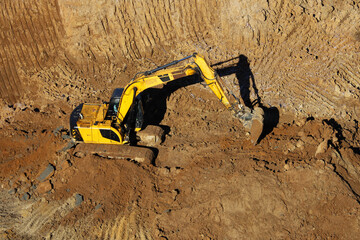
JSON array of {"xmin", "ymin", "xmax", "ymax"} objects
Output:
[{"xmin": 0, "ymin": 0, "xmax": 360, "ymax": 239}]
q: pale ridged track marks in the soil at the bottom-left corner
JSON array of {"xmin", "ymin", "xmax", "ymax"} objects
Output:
[{"xmin": 0, "ymin": 192, "xmax": 98, "ymax": 239}]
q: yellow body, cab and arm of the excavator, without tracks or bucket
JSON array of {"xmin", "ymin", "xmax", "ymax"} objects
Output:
[{"xmin": 70, "ymin": 53, "xmax": 260, "ymax": 144}]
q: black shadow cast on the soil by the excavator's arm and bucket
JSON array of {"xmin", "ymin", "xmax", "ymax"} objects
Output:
[{"xmin": 142, "ymin": 55, "xmax": 279, "ymax": 142}]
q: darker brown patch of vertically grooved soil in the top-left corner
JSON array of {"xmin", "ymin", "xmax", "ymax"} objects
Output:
[{"xmin": 0, "ymin": 0, "xmax": 62, "ymax": 103}]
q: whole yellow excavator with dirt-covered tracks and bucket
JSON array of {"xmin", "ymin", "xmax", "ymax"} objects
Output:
[{"xmin": 70, "ymin": 53, "xmax": 264, "ymax": 162}]
